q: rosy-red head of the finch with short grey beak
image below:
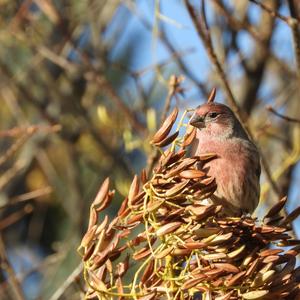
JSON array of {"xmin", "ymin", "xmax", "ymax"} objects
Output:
[{"xmin": 190, "ymin": 102, "xmax": 247, "ymax": 138}]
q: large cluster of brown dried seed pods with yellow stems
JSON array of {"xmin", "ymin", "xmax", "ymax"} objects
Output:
[{"xmin": 79, "ymin": 111, "xmax": 300, "ymax": 300}]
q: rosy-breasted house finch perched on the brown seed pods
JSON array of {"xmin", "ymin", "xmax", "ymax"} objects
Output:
[{"xmin": 190, "ymin": 102, "xmax": 260, "ymax": 216}]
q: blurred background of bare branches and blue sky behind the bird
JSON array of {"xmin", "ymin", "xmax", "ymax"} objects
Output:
[{"xmin": 0, "ymin": 0, "xmax": 300, "ymax": 300}]
